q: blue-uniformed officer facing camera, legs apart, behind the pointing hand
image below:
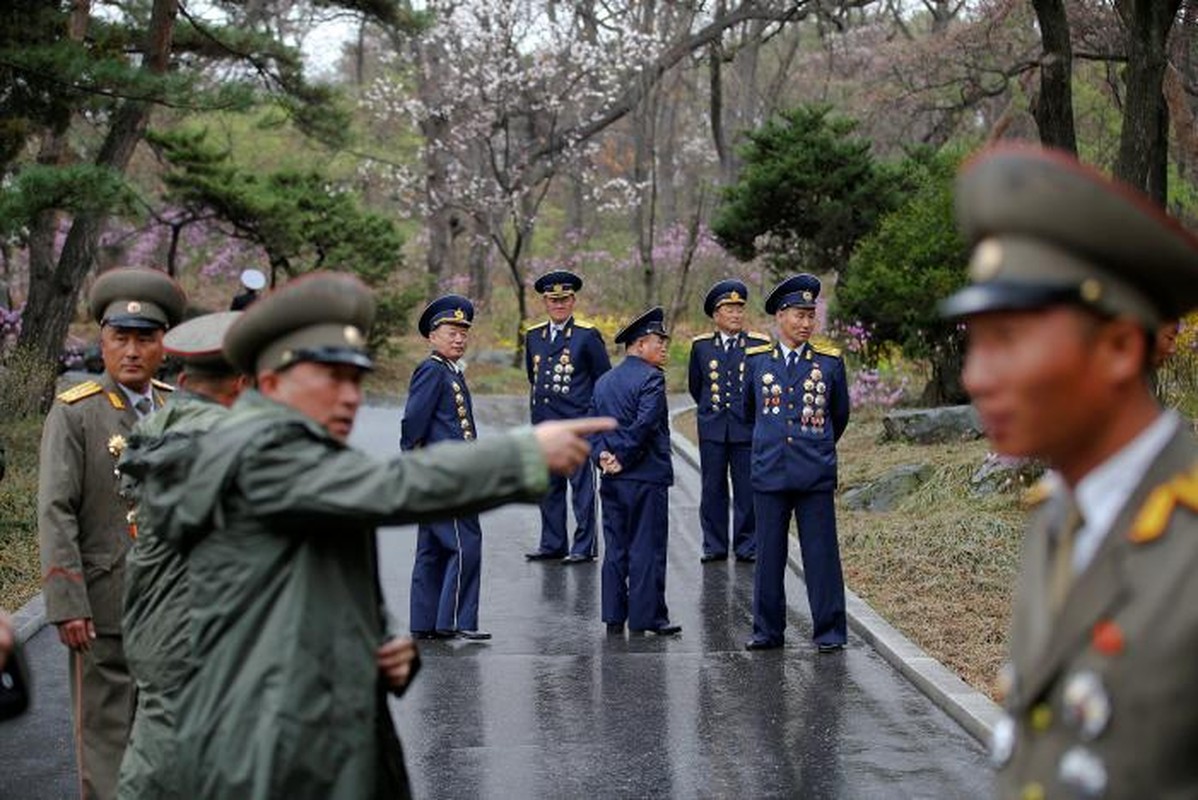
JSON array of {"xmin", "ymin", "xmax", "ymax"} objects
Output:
[{"xmin": 525, "ymin": 269, "xmax": 611, "ymax": 564}]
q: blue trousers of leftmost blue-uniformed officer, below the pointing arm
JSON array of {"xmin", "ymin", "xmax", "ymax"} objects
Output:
[{"xmin": 411, "ymin": 516, "xmax": 483, "ymax": 631}]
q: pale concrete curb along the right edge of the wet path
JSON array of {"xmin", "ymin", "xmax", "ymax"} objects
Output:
[{"xmin": 670, "ymin": 406, "xmax": 1003, "ymax": 744}]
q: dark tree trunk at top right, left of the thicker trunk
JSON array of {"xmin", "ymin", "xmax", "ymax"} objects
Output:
[{"xmin": 1031, "ymin": 0, "xmax": 1077, "ymax": 153}]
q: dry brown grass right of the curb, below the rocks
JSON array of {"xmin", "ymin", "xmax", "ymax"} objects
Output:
[{"xmin": 676, "ymin": 416, "xmax": 1024, "ymax": 695}]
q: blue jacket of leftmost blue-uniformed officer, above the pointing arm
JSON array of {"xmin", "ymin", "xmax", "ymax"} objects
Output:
[{"xmin": 399, "ymin": 353, "xmax": 477, "ymax": 450}]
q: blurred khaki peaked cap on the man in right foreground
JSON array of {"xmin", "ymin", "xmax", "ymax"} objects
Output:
[{"xmin": 940, "ymin": 145, "xmax": 1198, "ymax": 328}]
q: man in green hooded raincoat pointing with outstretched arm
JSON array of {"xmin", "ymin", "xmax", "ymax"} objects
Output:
[{"xmin": 140, "ymin": 273, "xmax": 615, "ymax": 800}]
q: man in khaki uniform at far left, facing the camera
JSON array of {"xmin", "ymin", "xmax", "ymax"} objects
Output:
[{"xmin": 37, "ymin": 269, "xmax": 186, "ymax": 798}]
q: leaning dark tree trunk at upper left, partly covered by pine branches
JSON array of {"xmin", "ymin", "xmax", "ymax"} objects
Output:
[{"xmin": 18, "ymin": 0, "xmax": 179, "ymax": 389}]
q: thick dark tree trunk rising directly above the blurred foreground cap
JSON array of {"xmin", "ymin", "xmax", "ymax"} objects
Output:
[{"xmin": 1114, "ymin": 0, "xmax": 1181, "ymax": 206}]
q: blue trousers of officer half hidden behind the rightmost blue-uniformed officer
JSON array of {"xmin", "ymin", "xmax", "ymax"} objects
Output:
[{"xmin": 698, "ymin": 438, "xmax": 757, "ymax": 558}]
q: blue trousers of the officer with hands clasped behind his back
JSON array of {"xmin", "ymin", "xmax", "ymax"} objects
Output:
[{"xmin": 599, "ymin": 480, "xmax": 670, "ymax": 630}]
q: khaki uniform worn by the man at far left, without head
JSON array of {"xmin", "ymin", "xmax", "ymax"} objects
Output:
[{"xmin": 37, "ymin": 375, "xmax": 168, "ymax": 798}]
